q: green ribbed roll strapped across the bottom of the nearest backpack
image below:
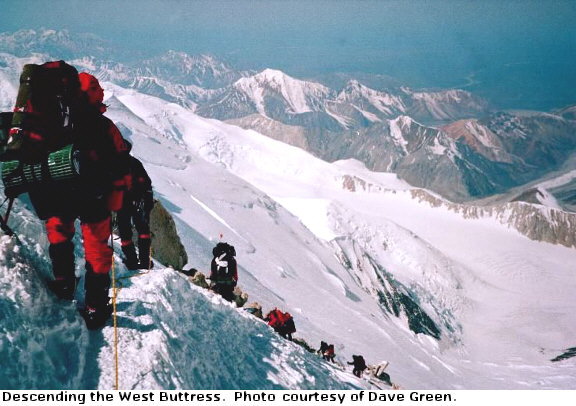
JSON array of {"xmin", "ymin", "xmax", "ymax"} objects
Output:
[{"xmin": 2, "ymin": 144, "xmax": 80, "ymax": 197}]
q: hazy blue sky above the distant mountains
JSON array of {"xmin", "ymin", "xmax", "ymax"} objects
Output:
[{"xmin": 0, "ymin": 0, "xmax": 576, "ymax": 108}]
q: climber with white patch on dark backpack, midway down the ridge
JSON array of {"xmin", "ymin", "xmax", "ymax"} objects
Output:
[{"xmin": 209, "ymin": 242, "xmax": 238, "ymax": 302}]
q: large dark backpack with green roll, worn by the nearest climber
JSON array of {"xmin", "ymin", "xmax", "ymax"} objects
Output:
[{"xmin": 0, "ymin": 61, "xmax": 87, "ymax": 196}]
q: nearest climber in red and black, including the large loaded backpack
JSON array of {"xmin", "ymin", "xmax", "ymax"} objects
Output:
[{"xmin": 2, "ymin": 61, "xmax": 130, "ymax": 329}]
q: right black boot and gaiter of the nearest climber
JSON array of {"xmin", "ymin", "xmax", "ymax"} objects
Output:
[{"xmin": 80, "ymin": 266, "xmax": 112, "ymax": 330}]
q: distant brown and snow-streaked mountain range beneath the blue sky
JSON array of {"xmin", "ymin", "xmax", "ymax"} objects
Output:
[{"xmin": 0, "ymin": 30, "xmax": 576, "ymax": 205}]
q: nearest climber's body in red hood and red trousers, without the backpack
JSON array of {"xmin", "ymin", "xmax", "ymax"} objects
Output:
[{"xmin": 30, "ymin": 73, "xmax": 130, "ymax": 328}]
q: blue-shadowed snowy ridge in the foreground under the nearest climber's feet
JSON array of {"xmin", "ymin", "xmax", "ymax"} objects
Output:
[{"xmin": 0, "ymin": 216, "xmax": 369, "ymax": 389}]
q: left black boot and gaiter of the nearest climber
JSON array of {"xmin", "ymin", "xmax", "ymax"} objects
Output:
[{"xmin": 48, "ymin": 241, "xmax": 78, "ymax": 300}]
